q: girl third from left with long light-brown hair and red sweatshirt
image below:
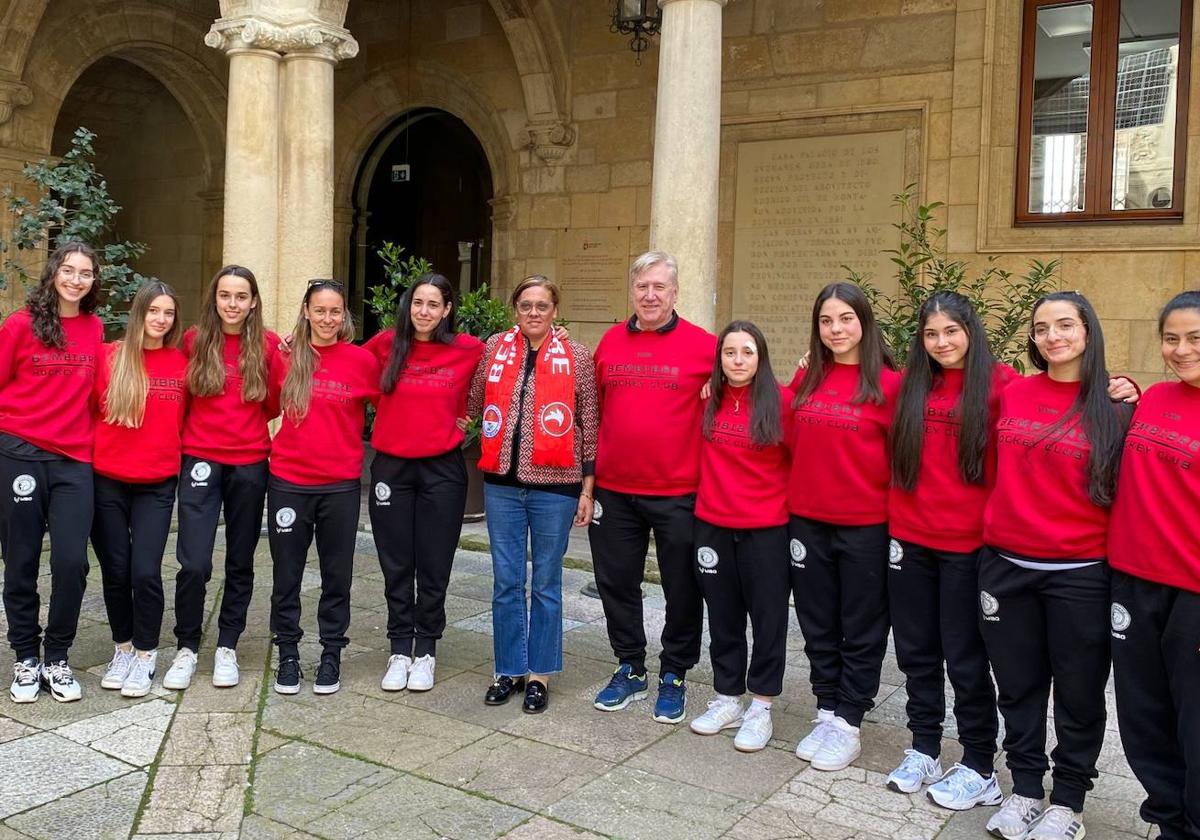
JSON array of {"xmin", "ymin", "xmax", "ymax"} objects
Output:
[{"xmin": 162, "ymin": 265, "xmax": 280, "ymax": 690}]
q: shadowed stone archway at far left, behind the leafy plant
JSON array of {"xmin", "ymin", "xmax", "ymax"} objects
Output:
[{"xmin": 50, "ymin": 56, "xmax": 208, "ymax": 323}]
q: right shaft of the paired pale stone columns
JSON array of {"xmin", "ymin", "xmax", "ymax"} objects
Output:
[{"xmin": 276, "ymin": 48, "xmax": 336, "ymax": 324}]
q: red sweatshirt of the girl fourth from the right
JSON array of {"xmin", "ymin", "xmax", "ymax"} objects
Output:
[{"xmin": 787, "ymin": 362, "xmax": 900, "ymax": 526}]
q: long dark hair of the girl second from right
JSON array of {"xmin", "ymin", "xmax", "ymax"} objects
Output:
[{"xmin": 1025, "ymin": 292, "xmax": 1132, "ymax": 508}]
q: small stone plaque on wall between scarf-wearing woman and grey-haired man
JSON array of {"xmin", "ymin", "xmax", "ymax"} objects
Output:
[{"xmin": 556, "ymin": 228, "xmax": 630, "ymax": 324}]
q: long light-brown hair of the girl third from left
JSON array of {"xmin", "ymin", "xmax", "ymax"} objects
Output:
[{"xmin": 187, "ymin": 265, "xmax": 266, "ymax": 402}]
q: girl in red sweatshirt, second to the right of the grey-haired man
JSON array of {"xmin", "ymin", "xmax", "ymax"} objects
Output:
[{"xmin": 787, "ymin": 283, "xmax": 900, "ymax": 770}]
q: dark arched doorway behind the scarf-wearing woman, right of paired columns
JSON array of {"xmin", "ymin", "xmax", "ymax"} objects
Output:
[{"xmin": 350, "ymin": 108, "xmax": 492, "ymax": 336}]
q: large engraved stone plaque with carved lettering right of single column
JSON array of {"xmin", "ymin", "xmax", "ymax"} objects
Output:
[{"xmin": 733, "ymin": 131, "xmax": 905, "ymax": 380}]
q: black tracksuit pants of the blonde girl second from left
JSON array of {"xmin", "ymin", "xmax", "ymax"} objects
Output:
[{"xmin": 91, "ymin": 473, "xmax": 178, "ymax": 650}]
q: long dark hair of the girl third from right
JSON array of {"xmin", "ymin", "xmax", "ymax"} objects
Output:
[{"xmin": 892, "ymin": 292, "xmax": 996, "ymax": 491}]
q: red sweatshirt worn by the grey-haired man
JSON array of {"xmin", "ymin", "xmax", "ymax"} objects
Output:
[{"xmin": 595, "ymin": 316, "xmax": 716, "ymax": 496}]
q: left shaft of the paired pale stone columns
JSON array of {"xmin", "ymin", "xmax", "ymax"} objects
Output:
[{"xmin": 205, "ymin": 30, "xmax": 282, "ymax": 325}]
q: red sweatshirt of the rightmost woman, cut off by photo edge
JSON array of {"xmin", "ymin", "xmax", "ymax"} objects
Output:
[{"xmin": 1109, "ymin": 382, "xmax": 1200, "ymax": 593}]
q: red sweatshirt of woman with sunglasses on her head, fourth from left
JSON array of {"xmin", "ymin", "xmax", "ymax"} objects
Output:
[{"xmin": 270, "ymin": 342, "xmax": 379, "ymax": 485}]
